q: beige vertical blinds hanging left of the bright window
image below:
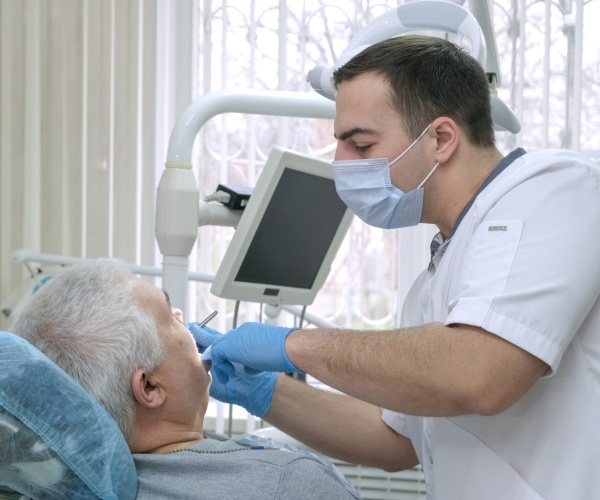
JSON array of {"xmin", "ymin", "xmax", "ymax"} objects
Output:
[{"xmin": 0, "ymin": 0, "xmax": 162, "ymax": 329}]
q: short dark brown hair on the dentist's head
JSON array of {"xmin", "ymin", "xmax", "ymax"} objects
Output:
[{"xmin": 333, "ymin": 35, "xmax": 495, "ymax": 147}]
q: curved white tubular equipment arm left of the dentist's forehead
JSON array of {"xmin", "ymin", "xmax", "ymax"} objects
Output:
[{"xmin": 155, "ymin": 90, "xmax": 335, "ymax": 317}]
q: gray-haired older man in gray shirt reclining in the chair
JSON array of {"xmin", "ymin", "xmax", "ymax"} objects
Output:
[{"xmin": 13, "ymin": 259, "xmax": 358, "ymax": 499}]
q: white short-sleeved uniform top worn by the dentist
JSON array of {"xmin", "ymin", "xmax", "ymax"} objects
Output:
[{"xmin": 382, "ymin": 150, "xmax": 600, "ymax": 500}]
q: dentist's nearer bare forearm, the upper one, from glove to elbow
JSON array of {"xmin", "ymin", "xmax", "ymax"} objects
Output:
[{"xmin": 285, "ymin": 323, "xmax": 547, "ymax": 416}]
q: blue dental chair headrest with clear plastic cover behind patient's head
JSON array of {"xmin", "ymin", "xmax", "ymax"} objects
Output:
[{"xmin": 0, "ymin": 331, "xmax": 137, "ymax": 500}]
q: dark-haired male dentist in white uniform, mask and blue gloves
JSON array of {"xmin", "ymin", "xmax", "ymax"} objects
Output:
[{"xmin": 188, "ymin": 36, "xmax": 600, "ymax": 500}]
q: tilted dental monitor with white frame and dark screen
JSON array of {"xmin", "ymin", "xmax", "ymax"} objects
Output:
[{"xmin": 211, "ymin": 147, "xmax": 352, "ymax": 305}]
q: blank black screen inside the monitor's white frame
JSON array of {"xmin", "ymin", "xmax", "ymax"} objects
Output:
[{"xmin": 235, "ymin": 168, "xmax": 346, "ymax": 289}]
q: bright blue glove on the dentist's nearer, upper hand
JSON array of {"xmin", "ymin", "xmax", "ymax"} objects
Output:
[{"xmin": 209, "ymin": 323, "xmax": 303, "ymax": 373}]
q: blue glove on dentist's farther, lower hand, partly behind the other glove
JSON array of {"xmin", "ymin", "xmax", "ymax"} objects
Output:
[{"xmin": 185, "ymin": 323, "xmax": 277, "ymax": 417}]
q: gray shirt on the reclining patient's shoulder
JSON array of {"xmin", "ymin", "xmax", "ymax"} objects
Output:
[{"xmin": 133, "ymin": 437, "xmax": 357, "ymax": 500}]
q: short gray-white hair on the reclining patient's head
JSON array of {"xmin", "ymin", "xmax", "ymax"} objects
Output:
[{"xmin": 12, "ymin": 259, "xmax": 165, "ymax": 439}]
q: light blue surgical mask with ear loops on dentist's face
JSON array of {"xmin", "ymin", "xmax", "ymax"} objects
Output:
[{"xmin": 332, "ymin": 125, "xmax": 439, "ymax": 229}]
